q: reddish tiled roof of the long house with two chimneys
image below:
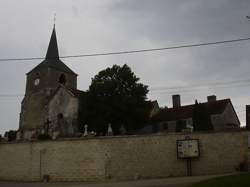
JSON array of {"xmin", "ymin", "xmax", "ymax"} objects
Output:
[{"xmin": 152, "ymin": 99, "xmax": 231, "ymax": 121}]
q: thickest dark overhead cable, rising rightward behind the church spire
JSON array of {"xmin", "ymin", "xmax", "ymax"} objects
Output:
[{"xmin": 0, "ymin": 38, "xmax": 250, "ymax": 61}]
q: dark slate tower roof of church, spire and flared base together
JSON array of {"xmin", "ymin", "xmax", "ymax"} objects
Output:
[{"xmin": 27, "ymin": 27, "xmax": 77, "ymax": 75}]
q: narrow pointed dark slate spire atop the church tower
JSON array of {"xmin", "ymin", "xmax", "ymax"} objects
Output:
[{"xmin": 45, "ymin": 25, "xmax": 59, "ymax": 60}]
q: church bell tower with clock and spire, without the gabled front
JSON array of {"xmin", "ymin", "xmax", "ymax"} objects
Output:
[{"xmin": 19, "ymin": 26, "xmax": 77, "ymax": 136}]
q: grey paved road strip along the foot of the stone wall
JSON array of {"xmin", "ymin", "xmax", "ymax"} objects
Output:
[{"xmin": 0, "ymin": 175, "xmax": 236, "ymax": 187}]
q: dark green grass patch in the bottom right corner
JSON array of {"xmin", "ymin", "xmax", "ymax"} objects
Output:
[{"xmin": 192, "ymin": 173, "xmax": 250, "ymax": 187}]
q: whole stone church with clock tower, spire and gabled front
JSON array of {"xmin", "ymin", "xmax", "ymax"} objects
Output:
[{"xmin": 17, "ymin": 26, "xmax": 83, "ymax": 139}]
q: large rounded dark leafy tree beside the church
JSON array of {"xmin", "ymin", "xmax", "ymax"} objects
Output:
[{"xmin": 80, "ymin": 64, "xmax": 150, "ymax": 134}]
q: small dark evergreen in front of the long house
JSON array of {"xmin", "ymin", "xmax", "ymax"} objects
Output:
[{"xmin": 193, "ymin": 101, "xmax": 213, "ymax": 131}]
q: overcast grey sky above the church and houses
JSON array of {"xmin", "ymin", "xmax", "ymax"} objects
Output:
[{"xmin": 0, "ymin": 0, "xmax": 250, "ymax": 134}]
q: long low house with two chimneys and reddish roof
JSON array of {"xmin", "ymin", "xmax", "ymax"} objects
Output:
[{"xmin": 151, "ymin": 95, "xmax": 240, "ymax": 132}]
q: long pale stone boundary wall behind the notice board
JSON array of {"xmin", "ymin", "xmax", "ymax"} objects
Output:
[{"xmin": 0, "ymin": 131, "xmax": 250, "ymax": 181}]
